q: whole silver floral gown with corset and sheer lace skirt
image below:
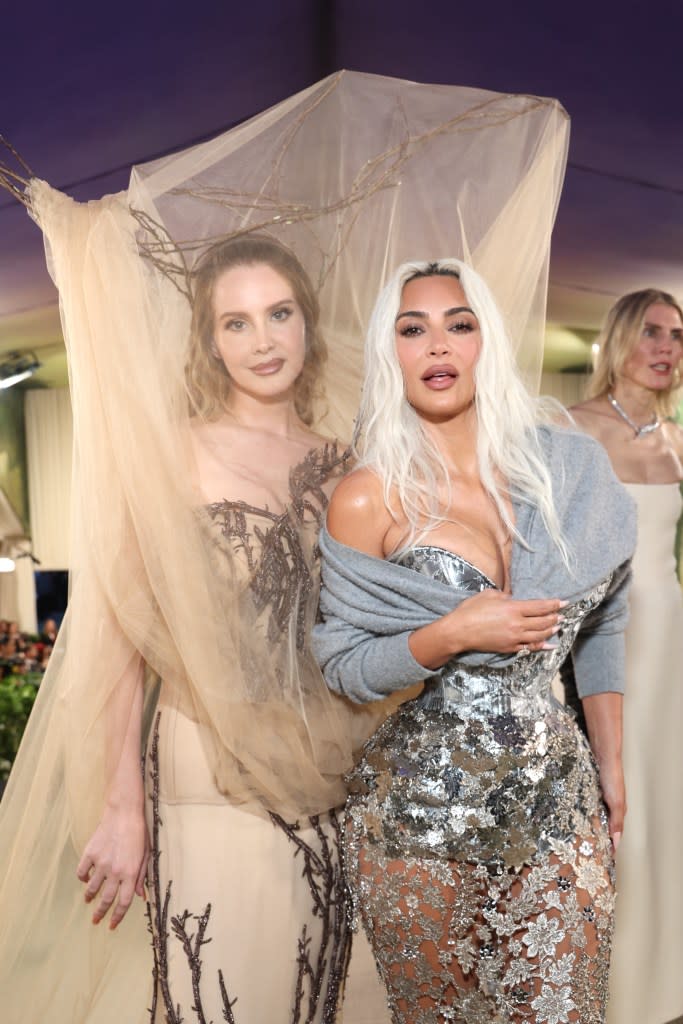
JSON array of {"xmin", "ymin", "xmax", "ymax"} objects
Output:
[{"xmin": 345, "ymin": 547, "xmax": 614, "ymax": 1024}]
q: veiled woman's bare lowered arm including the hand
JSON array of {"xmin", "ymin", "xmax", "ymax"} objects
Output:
[{"xmin": 77, "ymin": 653, "xmax": 150, "ymax": 929}]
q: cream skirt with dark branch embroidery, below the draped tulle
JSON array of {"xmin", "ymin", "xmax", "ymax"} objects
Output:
[{"xmin": 146, "ymin": 705, "xmax": 390, "ymax": 1024}]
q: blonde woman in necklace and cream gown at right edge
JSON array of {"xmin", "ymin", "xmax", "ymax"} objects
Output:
[{"xmin": 570, "ymin": 288, "xmax": 683, "ymax": 1024}]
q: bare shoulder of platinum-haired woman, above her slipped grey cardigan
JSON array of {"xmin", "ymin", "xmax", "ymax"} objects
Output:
[{"xmin": 328, "ymin": 468, "xmax": 393, "ymax": 558}]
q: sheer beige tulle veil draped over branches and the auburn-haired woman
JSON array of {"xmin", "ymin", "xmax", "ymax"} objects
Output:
[{"xmin": 0, "ymin": 73, "xmax": 567, "ymax": 1024}]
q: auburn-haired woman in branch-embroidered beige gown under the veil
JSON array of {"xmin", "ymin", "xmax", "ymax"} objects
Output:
[{"xmin": 72, "ymin": 236, "xmax": 387, "ymax": 1024}]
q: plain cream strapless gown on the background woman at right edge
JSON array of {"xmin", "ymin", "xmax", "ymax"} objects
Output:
[{"xmin": 607, "ymin": 483, "xmax": 683, "ymax": 1024}]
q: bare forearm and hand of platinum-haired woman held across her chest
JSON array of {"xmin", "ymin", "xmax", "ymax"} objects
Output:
[{"xmin": 410, "ymin": 590, "xmax": 564, "ymax": 669}]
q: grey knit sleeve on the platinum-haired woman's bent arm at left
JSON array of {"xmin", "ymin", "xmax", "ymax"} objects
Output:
[{"xmin": 313, "ymin": 614, "xmax": 429, "ymax": 703}]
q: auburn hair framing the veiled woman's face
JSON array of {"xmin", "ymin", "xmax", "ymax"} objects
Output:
[{"xmin": 185, "ymin": 234, "xmax": 327, "ymax": 425}]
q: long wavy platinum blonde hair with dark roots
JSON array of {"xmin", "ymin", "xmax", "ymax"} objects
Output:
[{"xmin": 356, "ymin": 259, "xmax": 569, "ymax": 565}]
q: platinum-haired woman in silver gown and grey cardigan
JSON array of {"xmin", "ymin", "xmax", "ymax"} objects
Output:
[{"xmin": 314, "ymin": 259, "xmax": 635, "ymax": 1024}]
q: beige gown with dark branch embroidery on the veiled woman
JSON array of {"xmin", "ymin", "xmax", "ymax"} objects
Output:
[{"xmin": 145, "ymin": 446, "xmax": 390, "ymax": 1024}]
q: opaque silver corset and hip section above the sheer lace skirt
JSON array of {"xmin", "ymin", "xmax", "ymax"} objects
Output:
[{"xmin": 349, "ymin": 547, "xmax": 609, "ymax": 868}]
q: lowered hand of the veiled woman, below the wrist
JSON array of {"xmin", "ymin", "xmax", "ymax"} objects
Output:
[{"xmin": 76, "ymin": 806, "xmax": 150, "ymax": 930}]
